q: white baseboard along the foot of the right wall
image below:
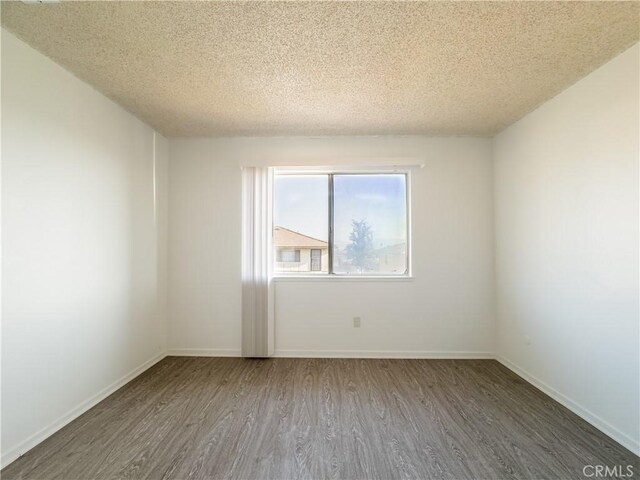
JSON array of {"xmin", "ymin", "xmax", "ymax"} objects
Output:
[{"xmin": 495, "ymin": 355, "xmax": 640, "ymax": 455}]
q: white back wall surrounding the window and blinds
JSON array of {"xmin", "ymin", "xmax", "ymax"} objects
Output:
[{"xmin": 169, "ymin": 137, "xmax": 495, "ymax": 356}]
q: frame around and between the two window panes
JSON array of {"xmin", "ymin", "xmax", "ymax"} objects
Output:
[{"xmin": 271, "ymin": 167, "xmax": 413, "ymax": 280}]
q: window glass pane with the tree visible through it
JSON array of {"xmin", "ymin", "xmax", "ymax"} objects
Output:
[{"xmin": 333, "ymin": 174, "xmax": 407, "ymax": 274}]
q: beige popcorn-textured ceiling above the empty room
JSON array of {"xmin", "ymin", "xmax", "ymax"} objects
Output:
[{"xmin": 1, "ymin": 1, "xmax": 640, "ymax": 136}]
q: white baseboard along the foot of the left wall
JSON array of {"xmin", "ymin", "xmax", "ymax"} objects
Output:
[{"xmin": 0, "ymin": 353, "xmax": 166, "ymax": 468}]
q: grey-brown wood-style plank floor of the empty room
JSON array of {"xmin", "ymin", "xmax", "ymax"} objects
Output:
[{"xmin": 1, "ymin": 357, "xmax": 640, "ymax": 480}]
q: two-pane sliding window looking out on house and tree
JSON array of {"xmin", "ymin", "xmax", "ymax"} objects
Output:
[{"xmin": 273, "ymin": 171, "xmax": 409, "ymax": 275}]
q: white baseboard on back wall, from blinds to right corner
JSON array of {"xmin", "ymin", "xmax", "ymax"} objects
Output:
[{"xmin": 273, "ymin": 350, "xmax": 495, "ymax": 360}]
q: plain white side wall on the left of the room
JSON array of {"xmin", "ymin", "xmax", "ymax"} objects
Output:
[{"xmin": 2, "ymin": 30, "xmax": 168, "ymax": 465}]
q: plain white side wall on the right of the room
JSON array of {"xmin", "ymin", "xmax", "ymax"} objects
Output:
[{"xmin": 494, "ymin": 45, "xmax": 640, "ymax": 452}]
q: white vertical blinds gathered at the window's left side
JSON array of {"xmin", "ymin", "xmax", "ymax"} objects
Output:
[{"xmin": 242, "ymin": 167, "xmax": 274, "ymax": 357}]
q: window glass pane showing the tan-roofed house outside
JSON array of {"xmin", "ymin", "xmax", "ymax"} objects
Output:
[{"xmin": 273, "ymin": 175, "xmax": 329, "ymax": 273}]
